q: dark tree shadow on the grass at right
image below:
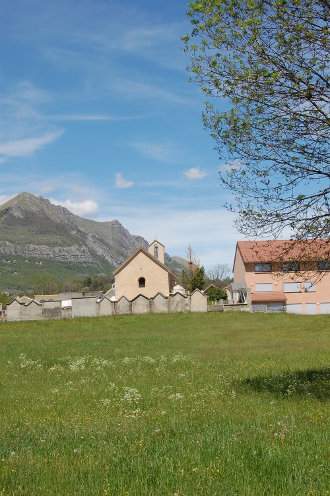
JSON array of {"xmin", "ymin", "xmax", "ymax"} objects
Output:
[{"xmin": 243, "ymin": 368, "xmax": 330, "ymax": 401}]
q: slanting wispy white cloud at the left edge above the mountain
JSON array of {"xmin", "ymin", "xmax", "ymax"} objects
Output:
[{"xmin": 0, "ymin": 130, "xmax": 64, "ymax": 160}]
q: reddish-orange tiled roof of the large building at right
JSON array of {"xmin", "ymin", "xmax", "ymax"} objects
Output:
[{"xmin": 237, "ymin": 239, "xmax": 330, "ymax": 263}]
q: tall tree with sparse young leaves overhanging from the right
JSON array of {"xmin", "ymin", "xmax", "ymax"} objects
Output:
[{"xmin": 183, "ymin": 0, "xmax": 330, "ymax": 250}]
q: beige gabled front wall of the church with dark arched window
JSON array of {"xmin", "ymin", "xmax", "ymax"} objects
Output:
[{"xmin": 115, "ymin": 252, "xmax": 169, "ymax": 300}]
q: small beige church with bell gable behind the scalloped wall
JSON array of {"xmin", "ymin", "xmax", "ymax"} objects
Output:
[{"xmin": 114, "ymin": 240, "xmax": 178, "ymax": 300}]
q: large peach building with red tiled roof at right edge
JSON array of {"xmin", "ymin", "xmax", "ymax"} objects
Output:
[{"xmin": 233, "ymin": 239, "xmax": 330, "ymax": 314}]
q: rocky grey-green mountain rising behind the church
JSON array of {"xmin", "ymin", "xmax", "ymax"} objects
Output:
[{"xmin": 0, "ymin": 193, "xmax": 180, "ymax": 290}]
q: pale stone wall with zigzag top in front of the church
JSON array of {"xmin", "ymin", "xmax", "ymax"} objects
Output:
[{"xmin": 6, "ymin": 289, "xmax": 207, "ymax": 321}]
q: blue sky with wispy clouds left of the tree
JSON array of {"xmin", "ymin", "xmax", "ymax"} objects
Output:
[{"xmin": 0, "ymin": 0, "xmax": 241, "ymax": 267}]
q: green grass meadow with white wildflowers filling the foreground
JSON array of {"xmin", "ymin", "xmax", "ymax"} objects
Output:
[{"xmin": 0, "ymin": 314, "xmax": 330, "ymax": 496}]
